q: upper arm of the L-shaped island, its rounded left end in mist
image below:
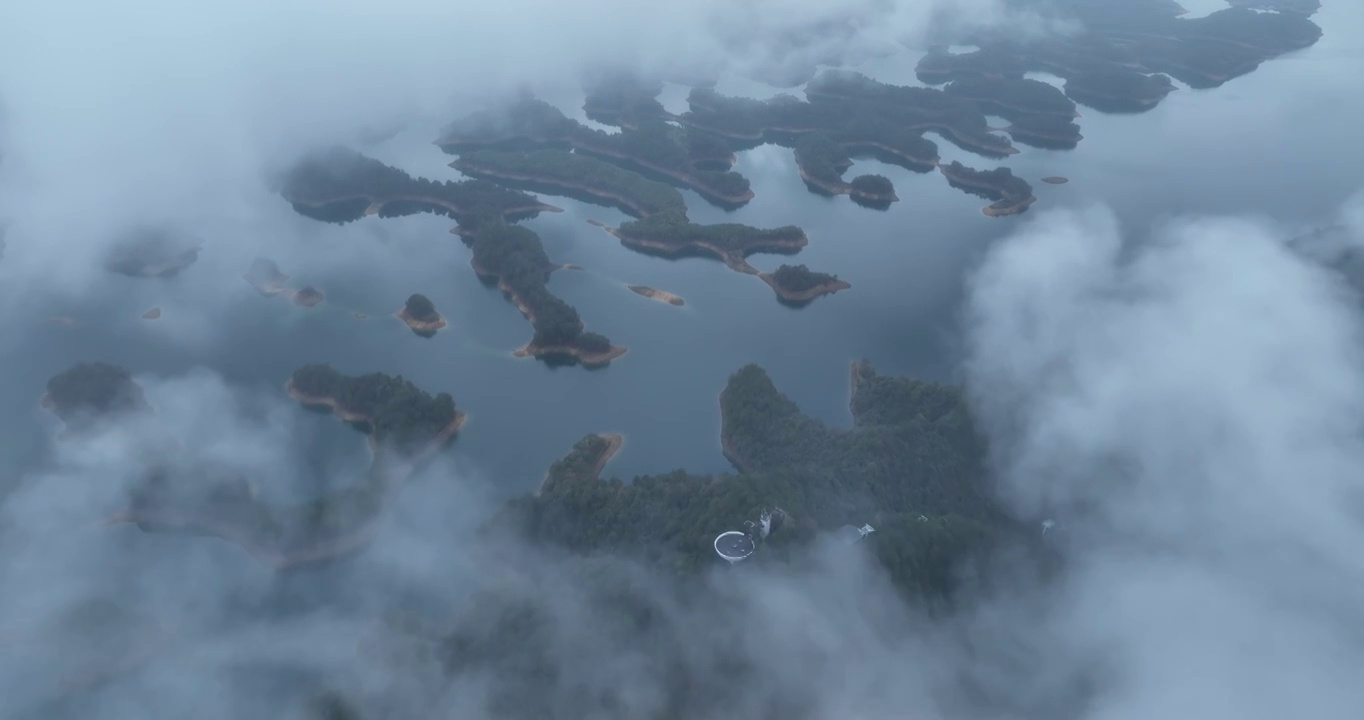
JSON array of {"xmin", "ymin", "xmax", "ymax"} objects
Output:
[{"xmin": 280, "ymin": 147, "xmax": 559, "ymax": 224}]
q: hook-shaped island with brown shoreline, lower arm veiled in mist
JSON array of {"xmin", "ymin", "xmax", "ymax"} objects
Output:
[{"xmin": 106, "ymin": 364, "xmax": 465, "ymax": 570}]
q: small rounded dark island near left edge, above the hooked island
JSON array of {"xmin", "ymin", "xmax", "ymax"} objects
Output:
[{"xmin": 41, "ymin": 363, "xmax": 151, "ymax": 431}]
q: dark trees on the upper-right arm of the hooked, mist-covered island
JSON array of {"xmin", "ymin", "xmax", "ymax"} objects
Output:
[{"xmin": 291, "ymin": 364, "xmax": 456, "ymax": 451}]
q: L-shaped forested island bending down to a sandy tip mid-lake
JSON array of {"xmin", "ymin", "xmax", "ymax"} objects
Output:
[{"xmin": 282, "ymin": 149, "xmax": 625, "ymax": 367}]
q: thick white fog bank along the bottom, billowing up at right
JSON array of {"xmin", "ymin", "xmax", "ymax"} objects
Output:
[{"xmin": 0, "ymin": 199, "xmax": 1364, "ymax": 719}]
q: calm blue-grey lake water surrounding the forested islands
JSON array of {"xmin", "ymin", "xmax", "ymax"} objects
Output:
[{"xmin": 0, "ymin": 7, "xmax": 1364, "ymax": 507}]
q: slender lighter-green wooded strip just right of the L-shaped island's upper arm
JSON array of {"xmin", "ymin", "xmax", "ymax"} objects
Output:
[{"xmin": 453, "ymin": 150, "xmax": 686, "ymax": 217}]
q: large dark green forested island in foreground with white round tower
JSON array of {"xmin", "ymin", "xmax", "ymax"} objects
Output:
[{"xmin": 492, "ymin": 361, "xmax": 1022, "ymax": 604}]
